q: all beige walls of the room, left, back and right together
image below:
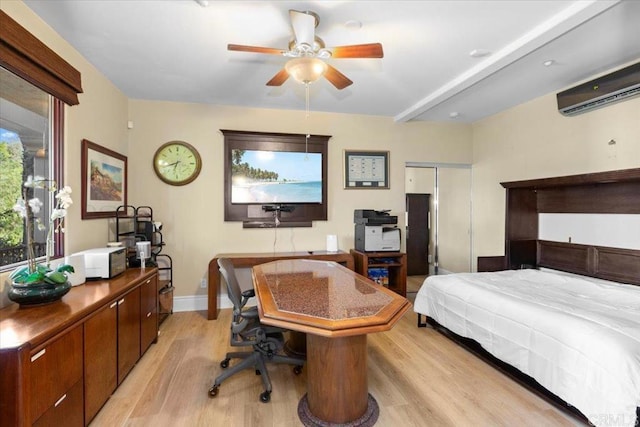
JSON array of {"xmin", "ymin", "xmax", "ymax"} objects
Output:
[{"xmin": 5, "ymin": 0, "xmax": 640, "ymax": 303}]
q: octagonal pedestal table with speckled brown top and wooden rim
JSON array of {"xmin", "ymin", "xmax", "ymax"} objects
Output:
[{"xmin": 252, "ymin": 259, "xmax": 410, "ymax": 426}]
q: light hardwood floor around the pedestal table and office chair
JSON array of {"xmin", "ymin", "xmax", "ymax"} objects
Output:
[{"xmin": 91, "ymin": 309, "xmax": 582, "ymax": 427}]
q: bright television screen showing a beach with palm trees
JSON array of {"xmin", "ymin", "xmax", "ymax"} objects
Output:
[{"xmin": 231, "ymin": 149, "xmax": 322, "ymax": 203}]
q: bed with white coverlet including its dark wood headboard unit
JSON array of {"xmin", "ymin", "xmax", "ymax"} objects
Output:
[{"xmin": 414, "ymin": 168, "xmax": 640, "ymax": 426}]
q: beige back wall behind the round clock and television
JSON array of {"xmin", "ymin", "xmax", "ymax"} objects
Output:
[{"xmin": 129, "ymin": 100, "xmax": 471, "ymax": 296}]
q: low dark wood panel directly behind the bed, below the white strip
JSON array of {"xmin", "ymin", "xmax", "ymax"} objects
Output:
[{"xmin": 537, "ymin": 240, "xmax": 640, "ymax": 286}]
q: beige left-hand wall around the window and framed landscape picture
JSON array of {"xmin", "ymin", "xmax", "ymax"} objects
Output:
[{"xmin": 0, "ymin": 0, "xmax": 128, "ymax": 306}]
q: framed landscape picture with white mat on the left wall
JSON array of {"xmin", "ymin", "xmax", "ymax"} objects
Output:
[{"xmin": 81, "ymin": 139, "xmax": 127, "ymax": 219}]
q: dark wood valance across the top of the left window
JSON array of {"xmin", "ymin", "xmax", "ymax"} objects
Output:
[{"xmin": 0, "ymin": 10, "xmax": 82, "ymax": 105}]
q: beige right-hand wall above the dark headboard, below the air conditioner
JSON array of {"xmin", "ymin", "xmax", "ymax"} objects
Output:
[{"xmin": 473, "ymin": 79, "xmax": 640, "ymax": 264}]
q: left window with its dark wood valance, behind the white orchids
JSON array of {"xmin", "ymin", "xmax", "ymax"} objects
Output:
[{"xmin": 0, "ymin": 10, "xmax": 82, "ymax": 270}]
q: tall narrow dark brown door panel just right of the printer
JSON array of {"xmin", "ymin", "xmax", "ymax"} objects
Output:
[{"xmin": 405, "ymin": 193, "xmax": 430, "ymax": 276}]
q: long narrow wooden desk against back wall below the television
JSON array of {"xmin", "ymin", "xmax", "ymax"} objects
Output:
[{"xmin": 207, "ymin": 251, "xmax": 353, "ymax": 320}]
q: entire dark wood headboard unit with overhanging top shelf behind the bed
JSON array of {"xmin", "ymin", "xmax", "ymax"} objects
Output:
[{"xmin": 501, "ymin": 168, "xmax": 640, "ymax": 285}]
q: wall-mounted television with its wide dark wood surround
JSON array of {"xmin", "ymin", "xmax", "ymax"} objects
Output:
[{"xmin": 221, "ymin": 130, "xmax": 330, "ymax": 227}]
